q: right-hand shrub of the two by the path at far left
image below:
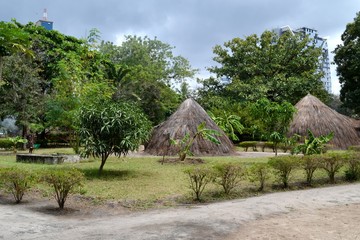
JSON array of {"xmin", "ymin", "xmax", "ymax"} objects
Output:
[{"xmin": 42, "ymin": 169, "xmax": 84, "ymax": 209}]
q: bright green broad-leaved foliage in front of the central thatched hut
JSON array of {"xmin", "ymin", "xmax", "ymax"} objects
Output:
[{"xmin": 170, "ymin": 122, "xmax": 220, "ymax": 161}]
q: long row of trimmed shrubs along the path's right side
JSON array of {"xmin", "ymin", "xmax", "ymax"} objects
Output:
[{"xmin": 185, "ymin": 151, "xmax": 360, "ymax": 200}]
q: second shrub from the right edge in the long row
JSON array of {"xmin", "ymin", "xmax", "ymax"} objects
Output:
[{"xmin": 320, "ymin": 153, "xmax": 346, "ymax": 183}]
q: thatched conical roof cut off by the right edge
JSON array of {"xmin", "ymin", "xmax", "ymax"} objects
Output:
[{"xmin": 288, "ymin": 94, "xmax": 360, "ymax": 149}]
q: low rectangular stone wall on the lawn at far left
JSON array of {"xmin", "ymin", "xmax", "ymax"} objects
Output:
[{"xmin": 16, "ymin": 154, "xmax": 80, "ymax": 164}]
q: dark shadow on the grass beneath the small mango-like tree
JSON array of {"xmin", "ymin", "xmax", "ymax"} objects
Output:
[{"xmin": 81, "ymin": 168, "xmax": 139, "ymax": 180}]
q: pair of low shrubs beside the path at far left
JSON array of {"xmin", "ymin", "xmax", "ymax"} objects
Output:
[{"xmin": 0, "ymin": 167, "xmax": 85, "ymax": 209}]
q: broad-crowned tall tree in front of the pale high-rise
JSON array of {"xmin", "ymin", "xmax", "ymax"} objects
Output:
[{"xmin": 210, "ymin": 31, "xmax": 327, "ymax": 104}]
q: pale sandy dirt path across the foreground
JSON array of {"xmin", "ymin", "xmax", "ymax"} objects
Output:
[{"xmin": 0, "ymin": 184, "xmax": 360, "ymax": 240}]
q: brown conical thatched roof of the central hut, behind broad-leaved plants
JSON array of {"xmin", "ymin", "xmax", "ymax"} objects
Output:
[{"xmin": 145, "ymin": 98, "xmax": 233, "ymax": 156}]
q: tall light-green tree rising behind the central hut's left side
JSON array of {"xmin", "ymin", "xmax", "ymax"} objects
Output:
[{"xmin": 99, "ymin": 36, "xmax": 196, "ymax": 124}]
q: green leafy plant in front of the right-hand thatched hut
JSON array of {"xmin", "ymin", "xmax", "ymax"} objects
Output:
[{"xmin": 294, "ymin": 130, "xmax": 334, "ymax": 155}]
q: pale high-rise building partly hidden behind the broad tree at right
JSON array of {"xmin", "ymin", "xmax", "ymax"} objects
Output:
[{"xmin": 274, "ymin": 26, "xmax": 332, "ymax": 93}]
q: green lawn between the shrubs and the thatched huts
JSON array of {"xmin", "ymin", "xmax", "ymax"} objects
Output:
[{"xmin": 0, "ymin": 149, "xmax": 354, "ymax": 207}]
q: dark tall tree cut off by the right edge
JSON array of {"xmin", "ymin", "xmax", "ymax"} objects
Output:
[{"xmin": 334, "ymin": 12, "xmax": 360, "ymax": 114}]
